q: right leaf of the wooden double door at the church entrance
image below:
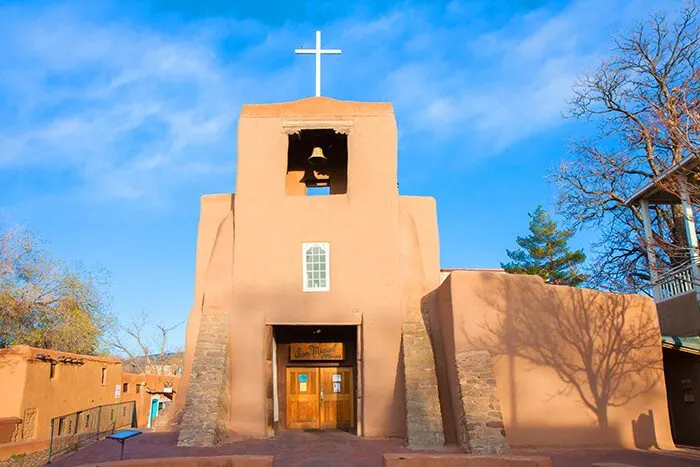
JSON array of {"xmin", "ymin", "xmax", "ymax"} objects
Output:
[{"xmin": 319, "ymin": 367, "xmax": 355, "ymax": 428}]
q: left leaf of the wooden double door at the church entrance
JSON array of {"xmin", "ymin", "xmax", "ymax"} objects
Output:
[{"xmin": 287, "ymin": 368, "xmax": 319, "ymax": 428}]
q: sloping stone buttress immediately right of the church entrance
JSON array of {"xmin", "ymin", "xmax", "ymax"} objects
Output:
[{"xmin": 401, "ymin": 322, "xmax": 445, "ymax": 450}]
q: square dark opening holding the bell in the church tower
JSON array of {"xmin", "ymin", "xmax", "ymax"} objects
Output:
[{"xmin": 286, "ymin": 129, "xmax": 348, "ymax": 196}]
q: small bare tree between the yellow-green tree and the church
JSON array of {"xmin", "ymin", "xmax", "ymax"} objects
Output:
[{"xmin": 110, "ymin": 311, "xmax": 182, "ymax": 375}]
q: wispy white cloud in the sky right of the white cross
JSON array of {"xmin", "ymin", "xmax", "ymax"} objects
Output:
[{"xmin": 380, "ymin": 0, "xmax": 664, "ymax": 157}]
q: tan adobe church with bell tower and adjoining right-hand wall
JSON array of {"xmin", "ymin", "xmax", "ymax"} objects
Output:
[{"xmin": 177, "ymin": 32, "xmax": 672, "ymax": 453}]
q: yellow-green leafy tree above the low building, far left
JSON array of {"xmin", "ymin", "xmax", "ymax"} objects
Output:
[{"xmin": 0, "ymin": 229, "xmax": 111, "ymax": 354}]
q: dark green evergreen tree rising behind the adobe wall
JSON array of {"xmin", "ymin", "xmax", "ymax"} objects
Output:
[{"xmin": 501, "ymin": 206, "xmax": 586, "ymax": 287}]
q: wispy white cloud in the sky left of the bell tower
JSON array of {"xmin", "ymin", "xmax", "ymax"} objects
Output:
[{"xmin": 0, "ymin": 4, "xmax": 243, "ymax": 203}]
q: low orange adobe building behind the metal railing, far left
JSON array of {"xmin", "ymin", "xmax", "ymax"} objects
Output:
[{"xmin": 0, "ymin": 345, "xmax": 180, "ymax": 459}]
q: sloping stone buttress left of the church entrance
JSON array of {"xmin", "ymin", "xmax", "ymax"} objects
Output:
[{"xmin": 177, "ymin": 297, "xmax": 230, "ymax": 446}]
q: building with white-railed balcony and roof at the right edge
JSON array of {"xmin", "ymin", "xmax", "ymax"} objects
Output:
[{"xmin": 625, "ymin": 155, "xmax": 700, "ymax": 446}]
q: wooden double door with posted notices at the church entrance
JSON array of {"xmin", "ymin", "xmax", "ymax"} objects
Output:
[{"xmin": 286, "ymin": 367, "xmax": 355, "ymax": 429}]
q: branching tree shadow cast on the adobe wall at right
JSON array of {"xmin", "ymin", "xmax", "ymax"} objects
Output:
[{"xmin": 463, "ymin": 275, "xmax": 662, "ymax": 448}]
